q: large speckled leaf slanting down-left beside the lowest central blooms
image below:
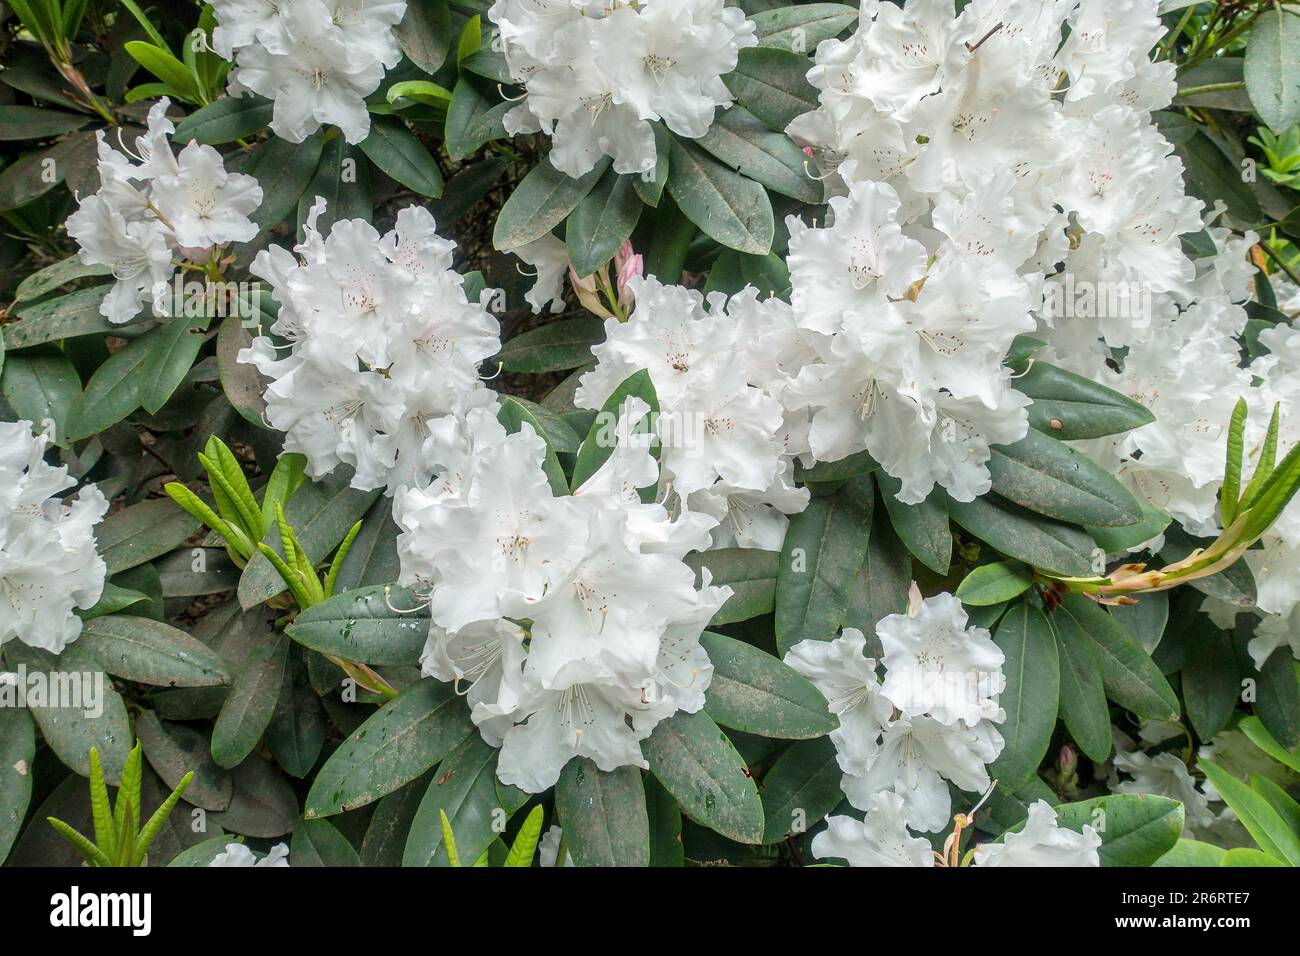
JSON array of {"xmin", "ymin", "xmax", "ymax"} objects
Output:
[{"xmin": 306, "ymin": 680, "xmax": 477, "ymax": 817}]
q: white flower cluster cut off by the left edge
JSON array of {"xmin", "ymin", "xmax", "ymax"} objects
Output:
[{"xmin": 0, "ymin": 421, "xmax": 108, "ymax": 654}]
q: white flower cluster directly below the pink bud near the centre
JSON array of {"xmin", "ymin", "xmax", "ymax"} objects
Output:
[{"xmin": 575, "ymin": 277, "xmax": 810, "ymax": 550}]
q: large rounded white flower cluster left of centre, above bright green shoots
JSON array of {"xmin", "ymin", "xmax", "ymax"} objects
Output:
[{"xmin": 239, "ymin": 198, "xmax": 501, "ymax": 494}]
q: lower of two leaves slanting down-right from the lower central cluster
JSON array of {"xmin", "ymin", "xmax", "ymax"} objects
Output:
[{"xmin": 641, "ymin": 710, "xmax": 763, "ymax": 843}]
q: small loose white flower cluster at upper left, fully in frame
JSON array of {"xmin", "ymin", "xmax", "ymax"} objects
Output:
[{"xmin": 68, "ymin": 96, "xmax": 261, "ymax": 323}]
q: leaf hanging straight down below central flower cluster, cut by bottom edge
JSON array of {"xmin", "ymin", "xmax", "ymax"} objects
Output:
[{"xmin": 555, "ymin": 757, "xmax": 650, "ymax": 866}]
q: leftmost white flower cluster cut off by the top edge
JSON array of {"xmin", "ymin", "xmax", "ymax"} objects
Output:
[{"xmin": 212, "ymin": 0, "xmax": 407, "ymax": 143}]
